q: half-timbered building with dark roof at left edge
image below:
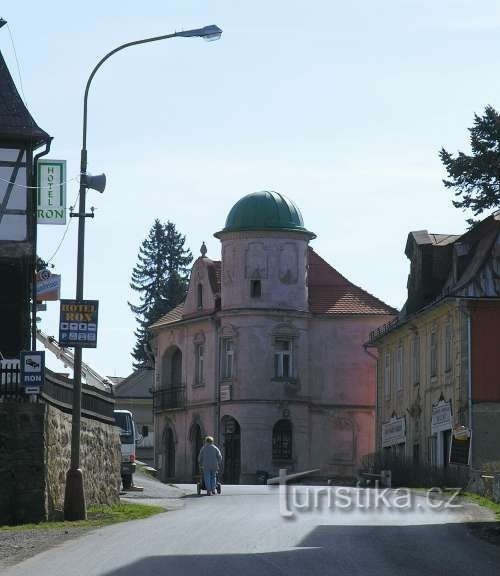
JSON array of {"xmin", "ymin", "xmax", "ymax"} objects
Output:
[{"xmin": 0, "ymin": 53, "xmax": 51, "ymax": 358}]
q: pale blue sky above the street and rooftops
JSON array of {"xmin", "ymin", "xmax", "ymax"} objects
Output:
[{"xmin": 0, "ymin": 0, "xmax": 500, "ymax": 376}]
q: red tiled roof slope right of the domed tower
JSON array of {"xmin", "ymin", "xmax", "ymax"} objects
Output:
[{"xmin": 308, "ymin": 248, "xmax": 398, "ymax": 315}]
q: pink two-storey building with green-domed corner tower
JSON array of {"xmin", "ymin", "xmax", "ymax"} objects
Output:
[{"xmin": 151, "ymin": 192, "xmax": 395, "ymax": 483}]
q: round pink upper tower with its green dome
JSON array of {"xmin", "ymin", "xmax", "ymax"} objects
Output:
[{"xmin": 215, "ymin": 191, "xmax": 315, "ymax": 311}]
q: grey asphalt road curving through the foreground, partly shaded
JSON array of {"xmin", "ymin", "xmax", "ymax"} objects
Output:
[{"xmin": 3, "ymin": 472, "xmax": 500, "ymax": 576}]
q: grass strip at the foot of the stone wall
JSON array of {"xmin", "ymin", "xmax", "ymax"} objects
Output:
[{"xmin": 0, "ymin": 502, "xmax": 165, "ymax": 531}]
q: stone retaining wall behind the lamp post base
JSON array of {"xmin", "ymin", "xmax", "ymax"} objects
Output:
[{"xmin": 0, "ymin": 402, "xmax": 120, "ymax": 525}]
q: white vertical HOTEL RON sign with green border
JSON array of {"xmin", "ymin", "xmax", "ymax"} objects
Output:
[{"xmin": 36, "ymin": 158, "xmax": 66, "ymax": 224}]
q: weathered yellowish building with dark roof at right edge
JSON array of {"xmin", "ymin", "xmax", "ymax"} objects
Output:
[{"xmin": 370, "ymin": 213, "xmax": 500, "ymax": 467}]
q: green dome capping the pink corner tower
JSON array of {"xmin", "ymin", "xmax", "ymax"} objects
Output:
[{"xmin": 216, "ymin": 191, "xmax": 314, "ymax": 238}]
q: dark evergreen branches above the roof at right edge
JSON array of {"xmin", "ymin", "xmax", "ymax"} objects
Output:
[{"xmin": 439, "ymin": 106, "xmax": 500, "ymax": 225}]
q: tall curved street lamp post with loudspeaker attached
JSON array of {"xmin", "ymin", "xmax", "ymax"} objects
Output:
[{"xmin": 63, "ymin": 23, "xmax": 222, "ymax": 520}]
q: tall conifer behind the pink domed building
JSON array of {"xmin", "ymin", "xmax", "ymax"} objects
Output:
[{"xmin": 128, "ymin": 219, "xmax": 193, "ymax": 370}]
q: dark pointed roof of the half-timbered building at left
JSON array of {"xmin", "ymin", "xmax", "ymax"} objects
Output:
[{"xmin": 0, "ymin": 52, "xmax": 50, "ymax": 146}]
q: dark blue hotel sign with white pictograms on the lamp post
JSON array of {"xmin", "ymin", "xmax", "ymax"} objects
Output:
[{"xmin": 59, "ymin": 300, "xmax": 99, "ymax": 348}]
